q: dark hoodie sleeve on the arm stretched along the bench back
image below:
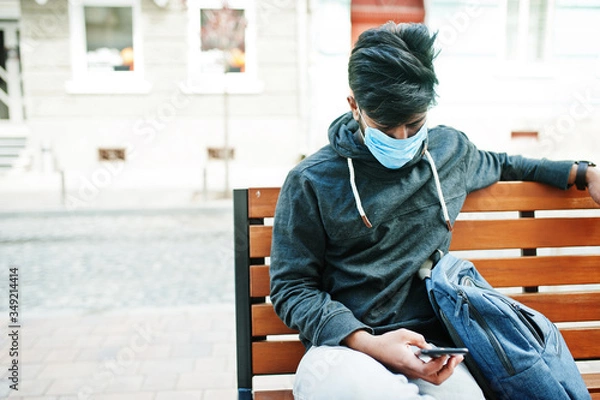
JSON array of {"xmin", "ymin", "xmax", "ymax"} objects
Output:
[{"xmin": 467, "ymin": 132, "xmax": 574, "ymax": 192}]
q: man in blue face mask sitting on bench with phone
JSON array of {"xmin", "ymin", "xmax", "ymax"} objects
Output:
[{"xmin": 271, "ymin": 23, "xmax": 600, "ymax": 400}]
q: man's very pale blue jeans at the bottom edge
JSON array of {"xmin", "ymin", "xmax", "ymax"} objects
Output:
[{"xmin": 294, "ymin": 346, "xmax": 484, "ymax": 400}]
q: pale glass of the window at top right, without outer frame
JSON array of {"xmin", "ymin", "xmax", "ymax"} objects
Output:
[{"xmin": 505, "ymin": 0, "xmax": 552, "ymax": 62}]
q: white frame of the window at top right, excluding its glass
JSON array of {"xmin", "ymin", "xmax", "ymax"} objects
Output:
[{"xmin": 500, "ymin": 0, "xmax": 555, "ymax": 78}]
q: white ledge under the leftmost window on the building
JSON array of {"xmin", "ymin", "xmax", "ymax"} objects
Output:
[{"xmin": 65, "ymin": 78, "xmax": 152, "ymax": 94}]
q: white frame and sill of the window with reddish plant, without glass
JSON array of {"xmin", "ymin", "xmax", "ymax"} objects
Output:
[{"xmin": 182, "ymin": 0, "xmax": 264, "ymax": 94}]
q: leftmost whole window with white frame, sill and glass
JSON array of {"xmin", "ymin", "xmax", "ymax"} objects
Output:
[{"xmin": 67, "ymin": 0, "xmax": 149, "ymax": 93}]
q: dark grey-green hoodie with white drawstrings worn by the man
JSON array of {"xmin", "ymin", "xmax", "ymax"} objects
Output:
[{"xmin": 271, "ymin": 113, "xmax": 573, "ymax": 347}]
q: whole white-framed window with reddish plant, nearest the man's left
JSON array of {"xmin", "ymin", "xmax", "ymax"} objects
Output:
[{"xmin": 186, "ymin": 0, "xmax": 262, "ymax": 93}]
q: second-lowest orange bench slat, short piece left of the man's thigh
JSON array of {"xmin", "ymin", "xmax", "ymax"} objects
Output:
[{"xmin": 252, "ymin": 340, "xmax": 305, "ymax": 375}]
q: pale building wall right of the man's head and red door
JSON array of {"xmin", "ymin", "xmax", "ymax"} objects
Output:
[{"xmin": 426, "ymin": 0, "xmax": 600, "ymax": 159}]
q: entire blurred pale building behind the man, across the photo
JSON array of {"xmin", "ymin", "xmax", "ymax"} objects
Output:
[{"xmin": 0, "ymin": 0, "xmax": 600, "ymax": 207}]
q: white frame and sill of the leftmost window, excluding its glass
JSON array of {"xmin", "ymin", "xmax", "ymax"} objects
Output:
[{"xmin": 66, "ymin": 0, "xmax": 151, "ymax": 94}]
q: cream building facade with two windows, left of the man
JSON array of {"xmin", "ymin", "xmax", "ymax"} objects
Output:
[{"xmin": 1, "ymin": 0, "xmax": 307, "ymax": 197}]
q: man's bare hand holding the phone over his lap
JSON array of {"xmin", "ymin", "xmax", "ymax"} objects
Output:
[{"xmin": 344, "ymin": 329, "xmax": 463, "ymax": 385}]
